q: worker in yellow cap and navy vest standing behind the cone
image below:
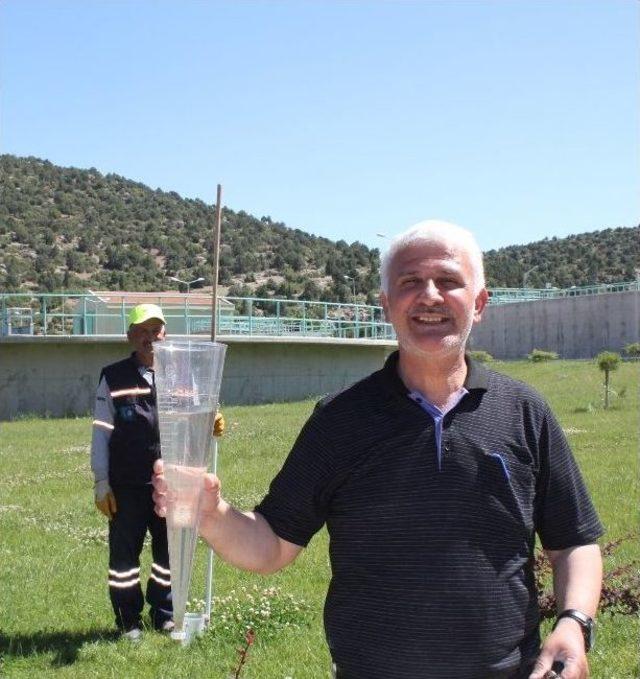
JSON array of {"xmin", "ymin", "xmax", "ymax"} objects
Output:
[{"xmin": 91, "ymin": 304, "xmax": 224, "ymax": 641}]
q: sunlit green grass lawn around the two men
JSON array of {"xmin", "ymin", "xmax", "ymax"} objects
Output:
[{"xmin": 0, "ymin": 361, "xmax": 640, "ymax": 679}]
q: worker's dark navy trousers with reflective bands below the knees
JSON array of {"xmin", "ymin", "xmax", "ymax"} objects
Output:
[{"xmin": 109, "ymin": 485, "xmax": 173, "ymax": 631}]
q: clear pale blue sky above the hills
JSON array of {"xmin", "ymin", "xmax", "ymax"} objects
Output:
[{"xmin": 0, "ymin": 0, "xmax": 640, "ymax": 250}]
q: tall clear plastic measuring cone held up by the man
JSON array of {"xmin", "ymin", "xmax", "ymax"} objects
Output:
[{"xmin": 154, "ymin": 341, "xmax": 227, "ymax": 636}]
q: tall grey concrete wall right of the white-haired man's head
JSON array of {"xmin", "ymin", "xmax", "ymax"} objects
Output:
[{"xmin": 471, "ymin": 291, "xmax": 640, "ymax": 358}]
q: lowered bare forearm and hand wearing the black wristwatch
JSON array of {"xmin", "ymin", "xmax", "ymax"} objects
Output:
[{"xmin": 530, "ymin": 544, "xmax": 602, "ymax": 679}]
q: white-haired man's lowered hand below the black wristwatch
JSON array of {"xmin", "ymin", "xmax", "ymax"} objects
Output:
[{"xmin": 529, "ymin": 618, "xmax": 589, "ymax": 679}]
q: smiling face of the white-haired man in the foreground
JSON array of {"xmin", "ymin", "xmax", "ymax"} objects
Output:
[{"xmin": 381, "ymin": 243, "xmax": 488, "ymax": 357}]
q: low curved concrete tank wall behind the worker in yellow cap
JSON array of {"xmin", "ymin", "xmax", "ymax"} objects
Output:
[{"xmin": 0, "ymin": 337, "xmax": 395, "ymax": 420}]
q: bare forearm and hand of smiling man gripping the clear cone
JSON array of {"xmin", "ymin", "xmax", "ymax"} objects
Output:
[{"xmin": 153, "ymin": 460, "xmax": 302, "ymax": 575}]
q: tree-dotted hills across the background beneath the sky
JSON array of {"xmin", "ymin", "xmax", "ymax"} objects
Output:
[{"xmin": 0, "ymin": 155, "xmax": 640, "ymax": 303}]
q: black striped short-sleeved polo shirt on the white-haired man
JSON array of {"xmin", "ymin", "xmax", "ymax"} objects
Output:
[{"xmin": 256, "ymin": 353, "xmax": 602, "ymax": 679}]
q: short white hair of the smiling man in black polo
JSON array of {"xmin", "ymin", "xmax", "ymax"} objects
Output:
[{"xmin": 380, "ymin": 219, "xmax": 485, "ymax": 294}]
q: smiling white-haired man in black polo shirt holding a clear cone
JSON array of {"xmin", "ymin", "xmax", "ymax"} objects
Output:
[{"xmin": 154, "ymin": 222, "xmax": 602, "ymax": 679}]
